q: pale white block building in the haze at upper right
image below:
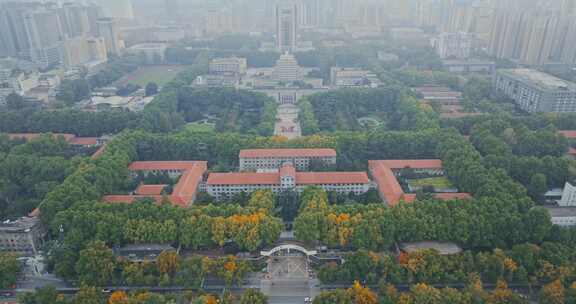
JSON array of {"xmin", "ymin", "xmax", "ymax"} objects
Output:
[{"xmin": 432, "ymin": 32, "xmax": 474, "ymax": 59}]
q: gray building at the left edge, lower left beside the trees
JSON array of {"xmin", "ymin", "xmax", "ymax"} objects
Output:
[{"xmin": 0, "ymin": 217, "xmax": 45, "ymax": 256}]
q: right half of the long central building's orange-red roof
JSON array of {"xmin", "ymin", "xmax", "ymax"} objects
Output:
[{"xmin": 296, "ymin": 172, "xmax": 370, "ymax": 185}]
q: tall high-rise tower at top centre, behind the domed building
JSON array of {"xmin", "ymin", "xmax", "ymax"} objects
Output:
[{"xmin": 276, "ymin": 1, "xmax": 298, "ymax": 52}]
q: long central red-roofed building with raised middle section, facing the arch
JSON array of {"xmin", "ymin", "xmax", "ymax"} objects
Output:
[{"xmin": 206, "ymin": 164, "xmax": 370, "ymax": 199}]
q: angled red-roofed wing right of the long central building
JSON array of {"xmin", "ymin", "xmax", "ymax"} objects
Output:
[{"xmin": 368, "ymin": 159, "xmax": 471, "ymax": 206}]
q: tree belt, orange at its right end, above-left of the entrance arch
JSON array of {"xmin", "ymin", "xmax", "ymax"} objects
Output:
[{"xmin": 50, "ymin": 192, "xmax": 282, "ymax": 284}]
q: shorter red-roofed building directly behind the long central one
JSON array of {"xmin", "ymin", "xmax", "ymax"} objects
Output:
[{"xmin": 240, "ymin": 149, "xmax": 336, "ymax": 171}]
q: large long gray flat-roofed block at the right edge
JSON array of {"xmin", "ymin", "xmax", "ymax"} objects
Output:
[{"xmin": 494, "ymin": 69, "xmax": 576, "ymax": 112}]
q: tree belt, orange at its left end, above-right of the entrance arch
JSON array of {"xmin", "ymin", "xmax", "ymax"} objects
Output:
[{"xmin": 294, "ymin": 189, "xmax": 552, "ymax": 250}]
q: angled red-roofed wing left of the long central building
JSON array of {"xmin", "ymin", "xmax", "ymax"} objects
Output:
[{"xmin": 103, "ymin": 161, "xmax": 208, "ymax": 207}]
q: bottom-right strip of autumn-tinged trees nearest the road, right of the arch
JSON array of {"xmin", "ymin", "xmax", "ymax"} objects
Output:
[{"xmin": 318, "ymin": 242, "xmax": 576, "ymax": 285}]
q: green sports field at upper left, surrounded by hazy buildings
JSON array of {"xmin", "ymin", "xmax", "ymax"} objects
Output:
[{"xmin": 118, "ymin": 65, "xmax": 185, "ymax": 87}]
